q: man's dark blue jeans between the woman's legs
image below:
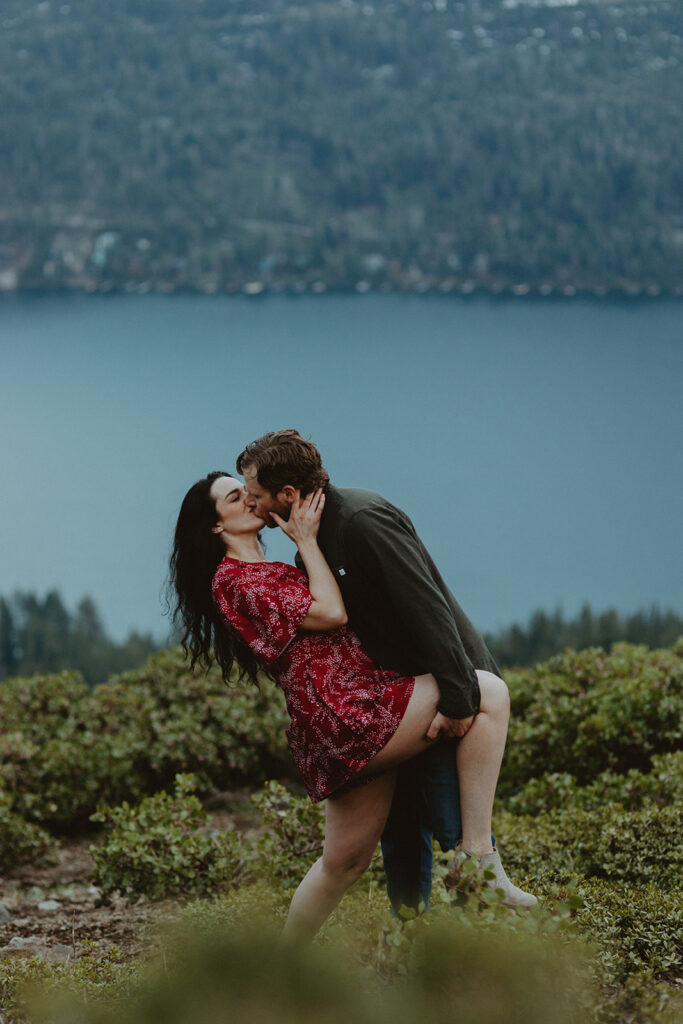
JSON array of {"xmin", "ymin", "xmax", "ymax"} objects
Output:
[{"xmin": 382, "ymin": 739, "xmax": 496, "ymax": 913}]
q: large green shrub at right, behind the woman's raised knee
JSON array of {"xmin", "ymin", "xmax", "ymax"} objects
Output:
[{"xmin": 499, "ymin": 641, "xmax": 683, "ymax": 798}]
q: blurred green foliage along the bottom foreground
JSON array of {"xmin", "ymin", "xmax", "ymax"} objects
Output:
[{"xmin": 6, "ymin": 917, "xmax": 592, "ymax": 1024}]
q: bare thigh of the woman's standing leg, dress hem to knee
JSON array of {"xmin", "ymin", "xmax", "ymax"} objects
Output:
[{"xmin": 323, "ymin": 771, "xmax": 396, "ymax": 871}]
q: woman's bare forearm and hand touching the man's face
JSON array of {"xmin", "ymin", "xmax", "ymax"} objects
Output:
[{"xmin": 270, "ymin": 490, "xmax": 348, "ymax": 632}]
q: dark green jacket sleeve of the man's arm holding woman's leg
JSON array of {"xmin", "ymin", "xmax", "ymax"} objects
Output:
[{"xmin": 345, "ymin": 506, "xmax": 480, "ymax": 718}]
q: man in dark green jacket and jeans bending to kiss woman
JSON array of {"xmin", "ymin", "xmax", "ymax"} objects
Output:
[{"xmin": 237, "ymin": 430, "xmax": 536, "ymax": 911}]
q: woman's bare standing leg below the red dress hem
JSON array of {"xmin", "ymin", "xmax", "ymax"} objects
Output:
[{"xmin": 283, "ymin": 770, "xmax": 396, "ymax": 939}]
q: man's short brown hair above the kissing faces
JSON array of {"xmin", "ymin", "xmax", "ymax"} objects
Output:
[{"xmin": 237, "ymin": 430, "xmax": 330, "ymax": 497}]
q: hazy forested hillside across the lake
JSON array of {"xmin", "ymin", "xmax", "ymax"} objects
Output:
[{"xmin": 0, "ymin": 0, "xmax": 683, "ymax": 294}]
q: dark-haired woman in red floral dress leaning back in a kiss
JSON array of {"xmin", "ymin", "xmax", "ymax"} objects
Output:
[{"xmin": 171, "ymin": 472, "xmax": 536, "ymax": 937}]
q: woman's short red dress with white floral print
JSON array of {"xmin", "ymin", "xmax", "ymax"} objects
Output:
[{"xmin": 212, "ymin": 558, "xmax": 415, "ymax": 803}]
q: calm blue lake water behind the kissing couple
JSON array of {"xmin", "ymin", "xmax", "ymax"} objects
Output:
[{"xmin": 0, "ymin": 295, "xmax": 683, "ymax": 636}]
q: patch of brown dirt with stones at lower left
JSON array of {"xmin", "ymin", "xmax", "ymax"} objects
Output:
[{"xmin": 0, "ymin": 810, "xmax": 246, "ymax": 963}]
